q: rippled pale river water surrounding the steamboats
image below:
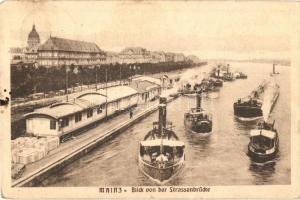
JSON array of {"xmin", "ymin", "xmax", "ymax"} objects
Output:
[{"xmin": 41, "ymin": 63, "xmax": 291, "ymax": 186}]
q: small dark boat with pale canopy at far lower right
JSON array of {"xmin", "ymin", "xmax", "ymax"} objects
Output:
[{"xmin": 248, "ymin": 121, "xmax": 279, "ymax": 161}]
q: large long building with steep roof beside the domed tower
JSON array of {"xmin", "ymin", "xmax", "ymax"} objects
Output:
[{"xmin": 37, "ymin": 37, "xmax": 106, "ymax": 67}]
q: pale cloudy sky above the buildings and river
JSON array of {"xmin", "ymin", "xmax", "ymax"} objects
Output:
[{"xmin": 0, "ymin": 0, "xmax": 295, "ymax": 59}]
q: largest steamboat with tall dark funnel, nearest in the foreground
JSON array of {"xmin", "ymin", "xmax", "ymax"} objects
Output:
[{"xmin": 139, "ymin": 97, "xmax": 185, "ymax": 184}]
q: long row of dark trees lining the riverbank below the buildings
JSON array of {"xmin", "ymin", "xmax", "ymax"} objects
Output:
[{"xmin": 11, "ymin": 61, "xmax": 204, "ymax": 98}]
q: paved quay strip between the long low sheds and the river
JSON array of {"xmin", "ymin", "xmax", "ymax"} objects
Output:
[{"xmin": 12, "ymin": 98, "xmax": 174, "ymax": 187}]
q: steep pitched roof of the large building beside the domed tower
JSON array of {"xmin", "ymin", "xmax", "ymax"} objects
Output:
[{"xmin": 38, "ymin": 37, "xmax": 104, "ymax": 53}]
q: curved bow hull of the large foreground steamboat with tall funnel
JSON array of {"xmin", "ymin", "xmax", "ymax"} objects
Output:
[{"xmin": 139, "ymin": 154, "xmax": 184, "ymax": 184}]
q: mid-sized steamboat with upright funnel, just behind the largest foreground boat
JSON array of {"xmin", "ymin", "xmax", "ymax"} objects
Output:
[{"xmin": 184, "ymin": 91, "xmax": 212, "ymax": 136}]
